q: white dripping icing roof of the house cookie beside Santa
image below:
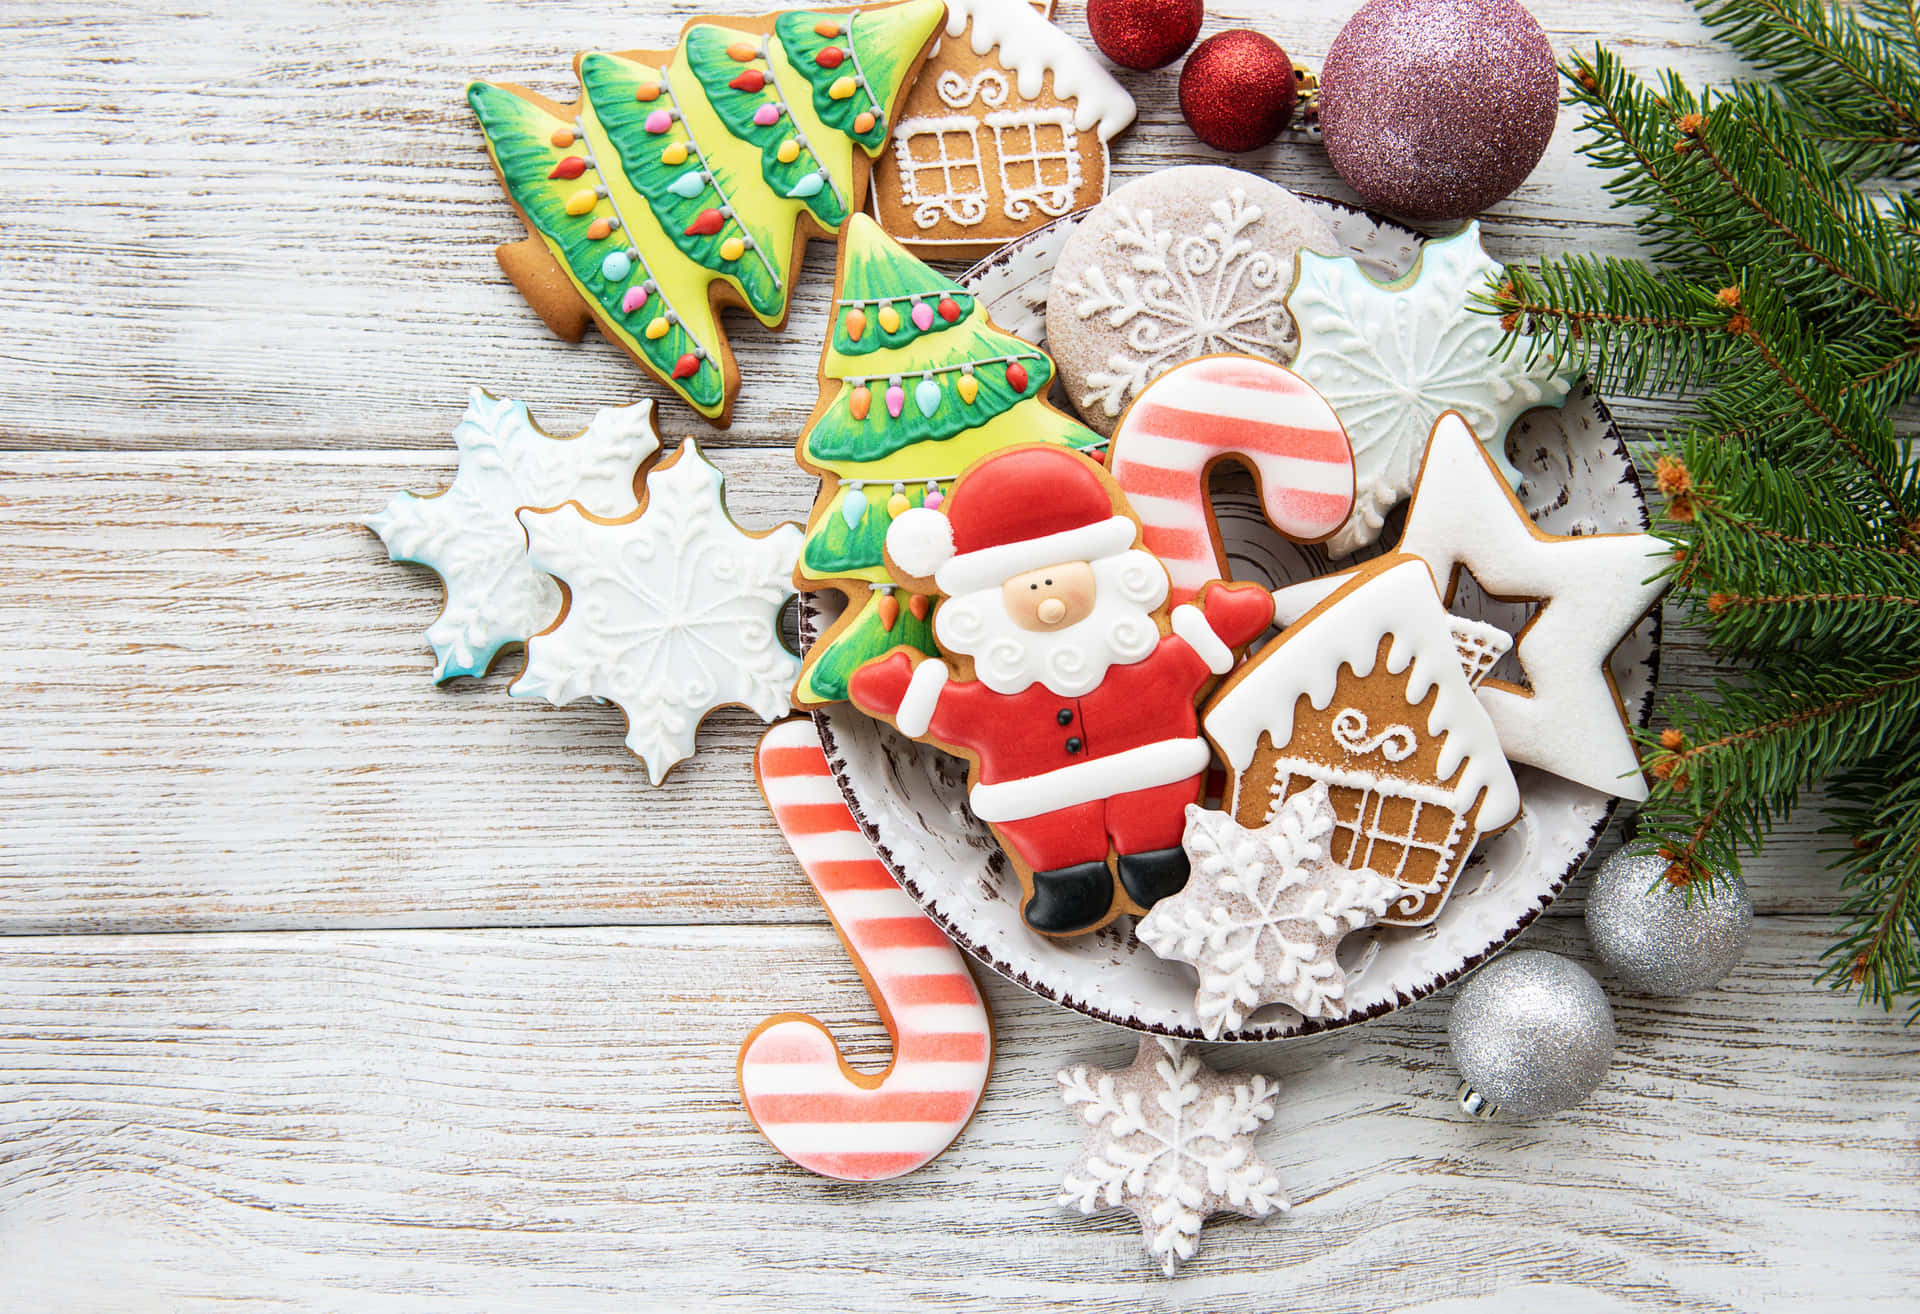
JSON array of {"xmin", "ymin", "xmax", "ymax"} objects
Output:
[{"xmin": 1204, "ymin": 559, "xmax": 1521, "ymax": 830}]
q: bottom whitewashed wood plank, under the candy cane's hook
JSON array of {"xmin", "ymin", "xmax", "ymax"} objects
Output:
[{"xmin": 0, "ymin": 918, "xmax": 1920, "ymax": 1312}]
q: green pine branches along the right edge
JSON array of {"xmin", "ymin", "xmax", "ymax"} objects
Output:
[{"xmin": 1482, "ymin": 0, "xmax": 1920, "ymax": 1016}]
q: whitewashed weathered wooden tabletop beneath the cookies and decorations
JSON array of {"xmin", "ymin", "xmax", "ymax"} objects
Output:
[{"xmin": 0, "ymin": 0, "xmax": 1920, "ymax": 1314}]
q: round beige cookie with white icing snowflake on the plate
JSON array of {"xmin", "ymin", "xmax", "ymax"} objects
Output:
[{"xmin": 1046, "ymin": 165, "xmax": 1340, "ymax": 436}]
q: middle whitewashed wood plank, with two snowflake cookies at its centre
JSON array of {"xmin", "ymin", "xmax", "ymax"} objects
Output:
[{"xmin": 0, "ymin": 457, "xmax": 1836, "ymax": 932}]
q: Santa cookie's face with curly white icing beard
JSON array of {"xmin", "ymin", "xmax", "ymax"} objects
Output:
[{"xmin": 933, "ymin": 548, "xmax": 1167, "ymax": 697}]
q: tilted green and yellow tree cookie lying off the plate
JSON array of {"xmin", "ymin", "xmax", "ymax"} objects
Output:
[{"xmin": 467, "ymin": 0, "xmax": 943, "ymax": 426}]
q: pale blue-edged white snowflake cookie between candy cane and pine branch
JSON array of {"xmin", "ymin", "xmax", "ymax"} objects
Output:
[{"xmin": 1286, "ymin": 223, "xmax": 1571, "ymax": 555}]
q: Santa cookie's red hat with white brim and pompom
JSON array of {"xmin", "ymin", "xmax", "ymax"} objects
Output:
[{"xmin": 887, "ymin": 444, "xmax": 1139, "ymax": 597}]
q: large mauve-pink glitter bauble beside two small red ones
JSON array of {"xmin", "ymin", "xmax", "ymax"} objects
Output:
[{"xmin": 1319, "ymin": 0, "xmax": 1559, "ymax": 221}]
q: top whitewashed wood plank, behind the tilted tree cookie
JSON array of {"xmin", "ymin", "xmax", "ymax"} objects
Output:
[{"xmin": 0, "ymin": 0, "xmax": 1734, "ymax": 448}]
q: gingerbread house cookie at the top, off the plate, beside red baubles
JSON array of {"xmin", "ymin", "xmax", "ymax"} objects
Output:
[{"xmin": 874, "ymin": 0, "xmax": 1133, "ymax": 257}]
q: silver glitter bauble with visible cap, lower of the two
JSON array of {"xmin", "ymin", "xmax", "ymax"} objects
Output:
[{"xmin": 1446, "ymin": 949, "xmax": 1613, "ymax": 1118}]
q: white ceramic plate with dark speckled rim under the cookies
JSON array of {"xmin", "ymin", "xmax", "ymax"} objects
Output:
[{"xmin": 803, "ymin": 202, "xmax": 1659, "ymax": 1041}]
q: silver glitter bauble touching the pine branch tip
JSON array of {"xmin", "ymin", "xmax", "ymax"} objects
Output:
[{"xmin": 1586, "ymin": 851, "xmax": 1753, "ymax": 995}]
